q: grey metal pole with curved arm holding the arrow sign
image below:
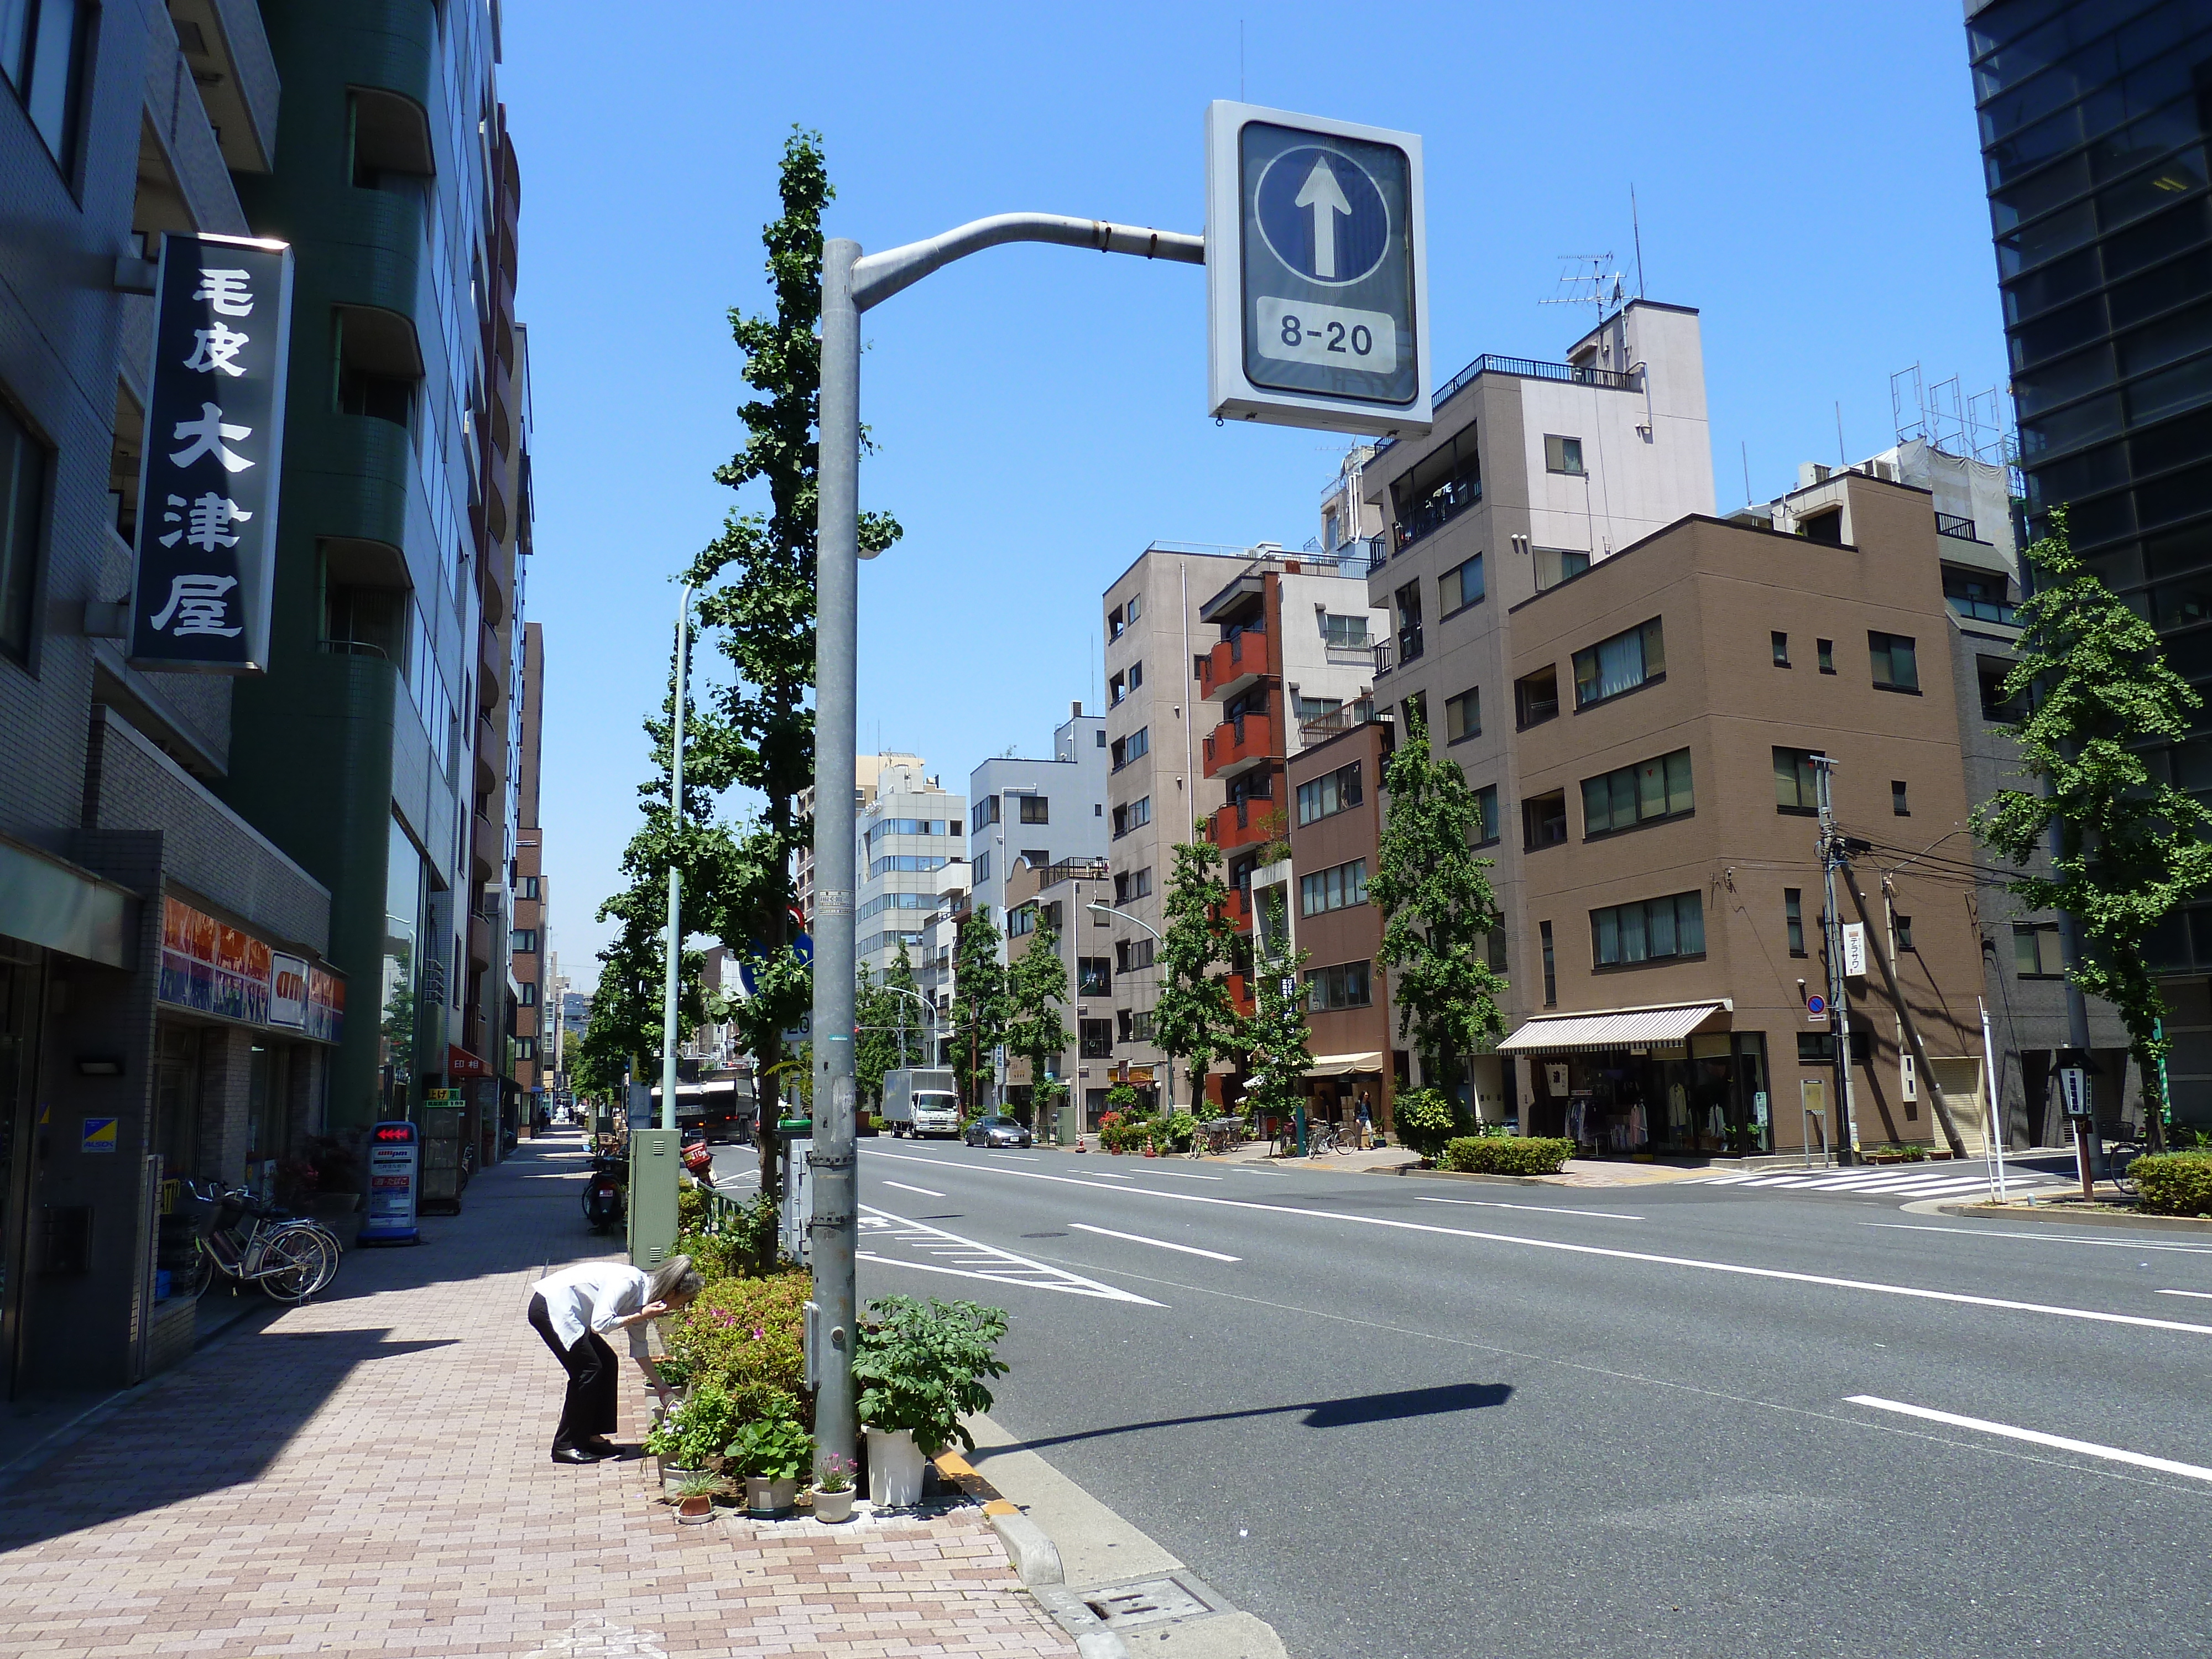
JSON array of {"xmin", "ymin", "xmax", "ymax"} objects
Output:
[{"xmin": 807, "ymin": 212, "xmax": 1206, "ymax": 1471}]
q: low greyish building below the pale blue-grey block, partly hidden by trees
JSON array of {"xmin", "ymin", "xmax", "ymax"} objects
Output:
[{"xmin": 1004, "ymin": 858, "xmax": 1115, "ymax": 1146}]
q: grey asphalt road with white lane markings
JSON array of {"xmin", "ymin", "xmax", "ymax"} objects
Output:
[{"xmin": 814, "ymin": 1141, "xmax": 2212, "ymax": 1659}]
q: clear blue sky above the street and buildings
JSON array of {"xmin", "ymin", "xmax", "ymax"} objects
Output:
[{"xmin": 502, "ymin": 0, "xmax": 2004, "ymax": 987}]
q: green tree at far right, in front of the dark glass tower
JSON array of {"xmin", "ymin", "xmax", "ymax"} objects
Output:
[{"xmin": 1973, "ymin": 507, "xmax": 2212, "ymax": 1148}]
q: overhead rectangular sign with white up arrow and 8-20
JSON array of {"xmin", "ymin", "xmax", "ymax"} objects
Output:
[{"xmin": 1206, "ymin": 102, "xmax": 1429, "ymax": 438}]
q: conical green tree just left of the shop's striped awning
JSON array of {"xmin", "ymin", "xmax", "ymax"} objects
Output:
[{"xmin": 1367, "ymin": 706, "xmax": 1506, "ymax": 1106}]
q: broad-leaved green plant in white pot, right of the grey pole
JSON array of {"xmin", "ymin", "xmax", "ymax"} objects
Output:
[{"xmin": 852, "ymin": 1296, "xmax": 1006, "ymax": 1509}]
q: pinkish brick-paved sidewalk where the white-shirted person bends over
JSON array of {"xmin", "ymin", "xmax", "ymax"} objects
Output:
[{"xmin": 0, "ymin": 1139, "xmax": 1073, "ymax": 1659}]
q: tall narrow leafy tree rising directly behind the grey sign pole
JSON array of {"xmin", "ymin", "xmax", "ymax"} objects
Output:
[{"xmin": 690, "ymin": 128, "xmax": 900, "ymax": 1239}]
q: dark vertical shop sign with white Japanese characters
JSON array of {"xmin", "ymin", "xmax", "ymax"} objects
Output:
[{"xmin": 131, "ymin": 230, "xmax": 292, "ymax": 675}]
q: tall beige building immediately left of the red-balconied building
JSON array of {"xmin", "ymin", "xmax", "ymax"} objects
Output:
[{"xmin": 1093, "ymin": 542, "xmax": 1252, "ymax": 1119}]
